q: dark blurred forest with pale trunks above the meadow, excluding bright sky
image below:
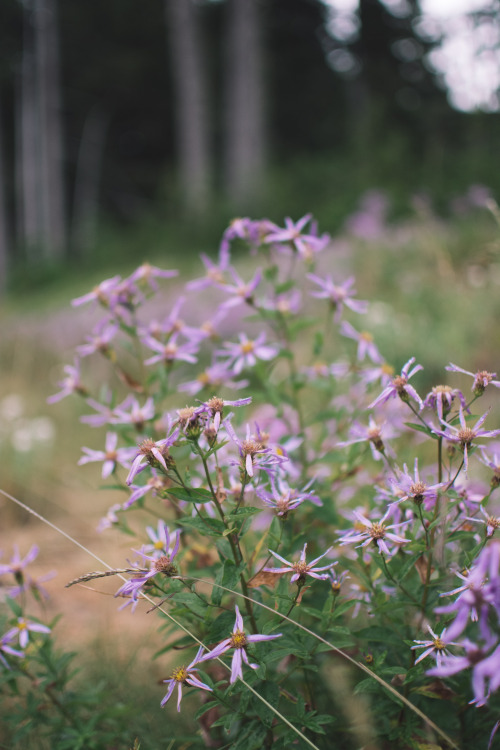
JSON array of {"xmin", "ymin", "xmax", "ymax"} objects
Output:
[{"xmin": 0, "ymin": 0, "xmax": 500, "ymax": 288}]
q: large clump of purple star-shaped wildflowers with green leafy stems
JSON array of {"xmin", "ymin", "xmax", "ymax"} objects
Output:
[{"xmin": 40, "ymin": 216, "xmax": 500, "ymax": 750}]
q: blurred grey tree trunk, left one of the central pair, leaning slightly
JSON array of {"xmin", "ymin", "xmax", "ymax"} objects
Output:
[{"xmin": 165, "ymin": 0, "xmax": 210, "ymax": 214}]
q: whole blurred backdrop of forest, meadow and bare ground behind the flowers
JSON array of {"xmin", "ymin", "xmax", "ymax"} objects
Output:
[{"xmin": 0, "ymin": 0, "xmax": 500, "ymax": 747}]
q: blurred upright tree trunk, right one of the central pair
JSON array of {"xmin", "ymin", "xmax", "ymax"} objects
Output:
[{"xmin": 225, "ymin": 0, "xmax": 266, "ymax": 204}]
